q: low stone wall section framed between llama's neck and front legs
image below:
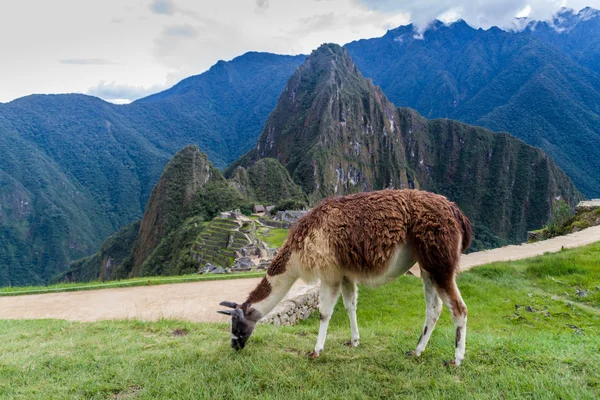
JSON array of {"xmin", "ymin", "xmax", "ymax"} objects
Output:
[{"xmin": 260, "ymin": 285, "xmax": 319, "ymax": 326}]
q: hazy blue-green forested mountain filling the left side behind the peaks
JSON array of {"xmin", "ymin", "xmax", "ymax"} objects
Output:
[{"xmin": 0, "ymin": 53, "xmax": 304, "ymax": 286}]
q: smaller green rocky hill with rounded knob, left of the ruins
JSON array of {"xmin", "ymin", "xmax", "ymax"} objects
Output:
[{"xmin": 60, "ymin": 146, "xmax": 304, "ymax": 282}]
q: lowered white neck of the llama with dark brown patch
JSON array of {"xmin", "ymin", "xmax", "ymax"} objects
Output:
[{"xmin": 244, "ymin": 246, "xmax": 298, "ymax": 318}]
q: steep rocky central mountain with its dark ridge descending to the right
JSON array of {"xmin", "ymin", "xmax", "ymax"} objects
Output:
[{"xmin": 234, "ymin": 45, "xmax": 581, "ymax": 242}]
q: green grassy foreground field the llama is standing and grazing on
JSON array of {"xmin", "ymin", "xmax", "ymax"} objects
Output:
[{"xmin": 0, "ymin": 244, "xmax": 600, "ymax": 399}]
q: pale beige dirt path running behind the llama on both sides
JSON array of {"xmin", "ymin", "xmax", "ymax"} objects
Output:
[{"xmin": 0, "ymin": 226, "xmax": 600, "ymax": 322}]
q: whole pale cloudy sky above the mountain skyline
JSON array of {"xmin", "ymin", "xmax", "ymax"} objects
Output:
[{"xmin": 0, "ymin": 0, "xmax": 600, "ymax": 102}]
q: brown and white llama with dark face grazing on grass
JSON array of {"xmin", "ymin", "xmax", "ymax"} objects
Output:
[{"xmin": 219, "ymin": 190, "xmax": 471, "ymax": 365}]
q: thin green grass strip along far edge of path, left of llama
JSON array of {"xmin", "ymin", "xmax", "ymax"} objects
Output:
[{"xmin": 0, "ymin": 272, "xmax": 265, "ymax": 297}]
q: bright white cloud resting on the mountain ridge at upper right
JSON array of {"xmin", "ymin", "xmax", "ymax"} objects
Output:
[{"xmin": 356, "ymin": 0, "xmax": 572, "ymax": 29}]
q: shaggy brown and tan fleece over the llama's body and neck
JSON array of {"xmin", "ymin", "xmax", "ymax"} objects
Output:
[{"xmin": 243, "ymin": 190, "xmax": 471, "ymax": 309}]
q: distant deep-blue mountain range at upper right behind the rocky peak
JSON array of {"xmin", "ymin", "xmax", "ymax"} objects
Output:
[{"xmin": 345, "ymin": 8, "xmax": 600, "ymax": 197}]
